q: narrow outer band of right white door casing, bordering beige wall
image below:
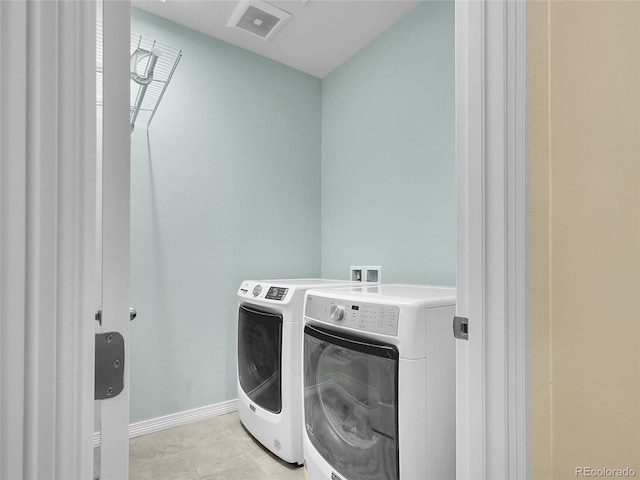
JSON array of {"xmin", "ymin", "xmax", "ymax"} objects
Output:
[{"xmin": 503, "ymin": 2, "xmax": 532, "ymax": 479}]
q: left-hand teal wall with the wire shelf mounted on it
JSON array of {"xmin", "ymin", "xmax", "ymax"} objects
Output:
[{"xmin": 130, "ymin": 9, "xmax": 321, "ymax": 422}]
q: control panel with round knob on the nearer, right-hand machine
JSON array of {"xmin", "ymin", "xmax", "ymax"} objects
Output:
[{"xmin": 305, "ymin": 295, "xmax": 400, "ymax": 336}]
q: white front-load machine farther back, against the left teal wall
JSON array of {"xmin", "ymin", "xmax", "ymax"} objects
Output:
[{"xmin": 237, "ymin": 278, "xmax": 352, "ymax": 464}]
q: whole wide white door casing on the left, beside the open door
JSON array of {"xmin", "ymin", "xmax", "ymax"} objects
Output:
[{"xmin": 0, "ymin": 1, "xmax": 96, "ymax": 478}]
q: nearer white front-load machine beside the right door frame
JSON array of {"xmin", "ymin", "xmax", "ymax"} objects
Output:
[{"xmin": 302, "ymin": 284, "xmax": 456, "ymax": 480}]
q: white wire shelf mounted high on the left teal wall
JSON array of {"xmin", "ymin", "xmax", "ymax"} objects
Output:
[{"xmin": 96, "ymin": 22, "xmax": 182, "ymax": 131}]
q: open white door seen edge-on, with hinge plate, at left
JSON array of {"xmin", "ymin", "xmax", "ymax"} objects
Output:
[{"xmin": 94, "ymin": 1, "xmax": 131, "ymax": 480}]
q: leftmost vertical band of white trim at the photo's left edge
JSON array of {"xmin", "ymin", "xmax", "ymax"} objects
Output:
[{"xmin": 0, "ymin": 2, "xmax": 27, "ymax": 478}]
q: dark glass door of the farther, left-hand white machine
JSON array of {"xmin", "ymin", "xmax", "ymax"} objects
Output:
[{"xmin": 238, "ymin": 304, "xmax": 282, "ymax": 413}]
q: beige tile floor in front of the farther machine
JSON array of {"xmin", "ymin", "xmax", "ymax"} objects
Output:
[{"xmin": 129, "ymin": 412, "xmax": 304, "ymax": 480}]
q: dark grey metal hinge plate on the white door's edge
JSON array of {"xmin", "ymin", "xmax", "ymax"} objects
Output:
[{"xmin": 94, "ymin": 332, "xmax": 124, "ymax": 400}]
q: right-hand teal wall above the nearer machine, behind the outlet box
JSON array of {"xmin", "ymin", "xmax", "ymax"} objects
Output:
[{"xmin": 321, "ymin": 1, "xmax": 456, "ymax": 285}]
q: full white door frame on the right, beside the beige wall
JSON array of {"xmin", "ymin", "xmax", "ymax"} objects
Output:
[{"xmin": 456, "ymin": 0, "xmax": 532, "ymax": 480}]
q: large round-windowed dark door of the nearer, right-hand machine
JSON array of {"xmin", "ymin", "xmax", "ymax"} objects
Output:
[{"xmin": 304, "ymin": 325, "xmax": 399, "ymax": 480}]
